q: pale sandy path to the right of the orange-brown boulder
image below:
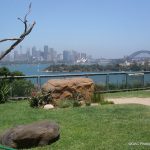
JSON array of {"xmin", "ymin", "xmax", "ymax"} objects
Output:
[{"xmin": 108, "ymin": 97, "xmax": 150, "ymax": 106}]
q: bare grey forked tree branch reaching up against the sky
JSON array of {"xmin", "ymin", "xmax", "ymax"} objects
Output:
[{"xmin": 0, "ymin": 3, "xmax": 35, "ymax": 60}]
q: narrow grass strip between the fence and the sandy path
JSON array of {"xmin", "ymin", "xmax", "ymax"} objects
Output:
[{"xmin": 103, "ymin": 90, "xmax": 150, "ymax": 98}]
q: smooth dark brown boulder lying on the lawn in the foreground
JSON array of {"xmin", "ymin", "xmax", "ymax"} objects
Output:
[{"xmin": 0, "ymin": 121, "xmax": 59, "ymax": 149}]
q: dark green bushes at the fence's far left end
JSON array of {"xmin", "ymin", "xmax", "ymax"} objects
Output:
[{"xmin": 0, "ymin": 67, "xmax": 34, "ymax": 101}]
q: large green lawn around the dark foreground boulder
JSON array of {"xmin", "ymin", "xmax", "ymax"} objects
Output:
[{"xmin": 0, "ymin": 101, "xmax": 150, "ymax": 150}]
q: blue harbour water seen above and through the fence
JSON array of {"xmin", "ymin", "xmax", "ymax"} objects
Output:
[{"xmin": 0, "ymin": 64, "xmax": 150, "ymax": 85}]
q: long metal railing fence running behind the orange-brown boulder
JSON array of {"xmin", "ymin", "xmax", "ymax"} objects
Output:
[{"xmin": 0, "ymin": 71, "xmax": 150, "ymax": 96}]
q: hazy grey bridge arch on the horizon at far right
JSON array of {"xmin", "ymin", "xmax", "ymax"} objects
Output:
[{"xmin": 126, "ymin": 50, "xmax": 150, "ymax": 61}]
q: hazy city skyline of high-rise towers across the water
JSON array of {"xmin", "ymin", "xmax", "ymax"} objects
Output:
[{"xmin": 2, "ymin": 45, "xmax": 89, "ymax": 63}]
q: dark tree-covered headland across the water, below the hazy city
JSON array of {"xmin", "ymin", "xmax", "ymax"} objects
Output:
[{"xmin": 44, "ymin": 62, "xmax": 150, "ymax": 72}]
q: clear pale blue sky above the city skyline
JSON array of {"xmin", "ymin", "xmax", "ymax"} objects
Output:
[{"xmin": 0, "ymin": 0, "xmax": 150, "ymax": 58}]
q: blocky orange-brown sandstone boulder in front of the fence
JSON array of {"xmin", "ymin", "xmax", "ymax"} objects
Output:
[{"xmin": 42, "ymin": 78, "xmax": 94, "ymax": 105}]
